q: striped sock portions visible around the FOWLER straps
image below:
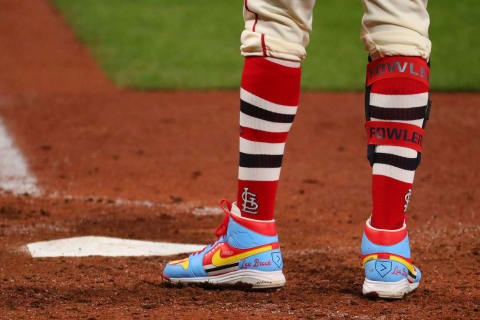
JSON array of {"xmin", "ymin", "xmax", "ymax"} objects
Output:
[{"xmin": 367, "ymin": 58, "xmax": 429, "ymax": 230}]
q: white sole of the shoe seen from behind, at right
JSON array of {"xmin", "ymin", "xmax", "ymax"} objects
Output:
[{"xmin": 362, "ymin": 279, "xmax": 419, "ymax": 299}]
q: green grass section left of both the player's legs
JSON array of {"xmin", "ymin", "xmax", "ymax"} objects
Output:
[{"xmin": 55, "ymin": 0, "xmax": 243, "ymax": 89}]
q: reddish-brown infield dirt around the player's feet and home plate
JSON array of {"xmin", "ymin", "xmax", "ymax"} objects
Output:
[{"xmin": 0, "ymin": 0, "xmax": 480, "ymax": 319}]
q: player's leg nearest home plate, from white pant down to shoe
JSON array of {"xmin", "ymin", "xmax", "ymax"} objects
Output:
[{"xmin": 162, "ymin": 0, "xmax": 314, "ymax": 288}]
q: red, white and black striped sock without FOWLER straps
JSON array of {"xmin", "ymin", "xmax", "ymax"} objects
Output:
[{"xmin": 237, "ymin": 57, "xmax": 301, "ymax": 220}]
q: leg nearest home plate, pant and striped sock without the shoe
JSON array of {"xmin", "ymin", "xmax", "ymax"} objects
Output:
[{"xmin": 236, "ymin": 0, "xmax": 314, "ymax": 220}]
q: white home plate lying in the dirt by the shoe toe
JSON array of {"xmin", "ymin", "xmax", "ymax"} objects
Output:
[{"xmin": 25, "ymin": 236, "xmax": 205, "ymax": 258}]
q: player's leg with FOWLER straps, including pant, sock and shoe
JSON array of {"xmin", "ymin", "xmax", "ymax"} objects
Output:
[{"xmin": 362, "ymin": 0, "xmax": 431, "ymax": 298}]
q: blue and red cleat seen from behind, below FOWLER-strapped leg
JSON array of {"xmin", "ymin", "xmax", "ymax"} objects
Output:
[{"xmin": 362, "ymin": 219, "xmax": 422, "ymax": 299}]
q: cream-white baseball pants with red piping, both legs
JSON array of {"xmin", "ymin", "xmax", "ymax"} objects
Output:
[{"xmin": 241, "ymin": 0, "xmax": 431, "ymax": 61}]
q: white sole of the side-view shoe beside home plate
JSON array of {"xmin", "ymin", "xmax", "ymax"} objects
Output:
[{"xmin": 162, "ymin": 270, "xmax": 285, "ymax": 289}]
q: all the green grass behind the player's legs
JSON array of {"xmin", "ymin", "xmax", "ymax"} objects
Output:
[{"xmin": 53, "ymin": 0, "xmax": 480, "ymax": 90}]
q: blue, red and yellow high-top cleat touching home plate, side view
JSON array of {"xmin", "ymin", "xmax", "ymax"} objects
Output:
[{"xmin": 162, "ymin": 200, "xmax": 285, "ymax": 289}]
